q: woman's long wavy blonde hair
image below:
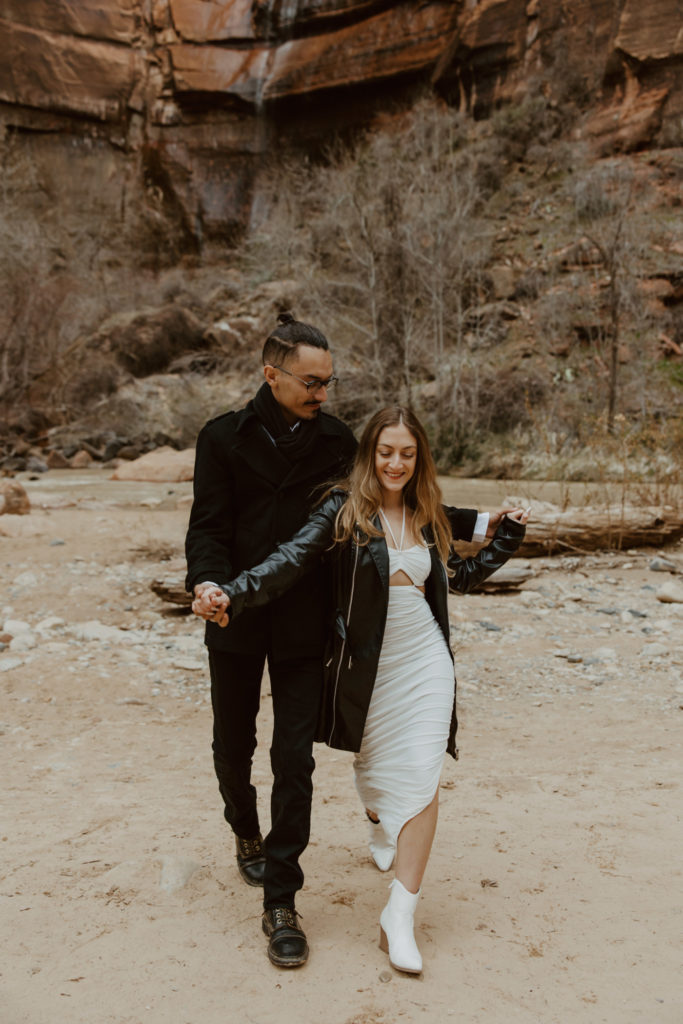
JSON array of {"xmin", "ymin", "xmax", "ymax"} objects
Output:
[{"xmin": 334, "ymin": 406, "xmax": 452, "ymax": 562}]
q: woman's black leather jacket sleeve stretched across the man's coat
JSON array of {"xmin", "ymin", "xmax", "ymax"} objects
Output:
[{"xmin": 220, "ymin": 492, "xmax": 344, "ymax": 617}]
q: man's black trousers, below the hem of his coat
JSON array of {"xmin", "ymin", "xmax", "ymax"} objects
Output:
[{"xmin": 209, "ymin": 649, "xmax": 323, "ymax": 909}]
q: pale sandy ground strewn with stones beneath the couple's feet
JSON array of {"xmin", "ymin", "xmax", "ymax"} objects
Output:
[{"xmin": 0, "ymin": 471, "xmax": 683, "ymax": 1024}]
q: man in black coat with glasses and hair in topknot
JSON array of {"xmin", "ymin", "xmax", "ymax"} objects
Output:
[{"xmin": 185, "ymin": 313, "xmax": 501, "ymax": 968}]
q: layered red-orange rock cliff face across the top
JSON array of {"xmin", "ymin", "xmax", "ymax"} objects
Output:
[{"xmin": 0, "ymin": 0, "xmax": 683, "ymax": 239}]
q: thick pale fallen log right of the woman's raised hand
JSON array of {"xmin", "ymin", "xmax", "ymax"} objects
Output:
[{"xmin": 505, "ymin": 498, "xmax": 683, "ymax": 557}]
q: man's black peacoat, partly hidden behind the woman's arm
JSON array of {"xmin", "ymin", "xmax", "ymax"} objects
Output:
[{"xmin": 185, "ymin": 401, "xmax": 356, "ymax": 660}]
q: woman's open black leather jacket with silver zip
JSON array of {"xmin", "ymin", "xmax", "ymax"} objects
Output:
[{"xmin": 222, "ymin": 492, "xmax": 525, "ymax": 757}]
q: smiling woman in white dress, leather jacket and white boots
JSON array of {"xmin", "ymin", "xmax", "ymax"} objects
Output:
[{"xmin": 217, "ymin": 406, "xmax": 527, "ymax": 974}]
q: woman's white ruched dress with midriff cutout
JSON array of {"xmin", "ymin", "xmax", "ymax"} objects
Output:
[{"xmin": 353, "ymin": 538, "xmax": 455, "ymax": 849}]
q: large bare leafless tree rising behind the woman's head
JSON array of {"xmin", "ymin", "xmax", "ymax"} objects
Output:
[{"xmin": 245, "ymin": 104, "xmax": 489, "ymax": 440}]
